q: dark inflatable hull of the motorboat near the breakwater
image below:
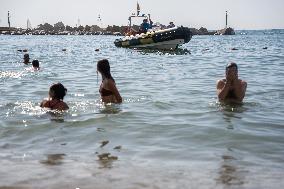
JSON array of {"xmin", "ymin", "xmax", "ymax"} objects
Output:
[{"xmin": 114, "ymin": 26, "xmax": 192, "ymax": 50}]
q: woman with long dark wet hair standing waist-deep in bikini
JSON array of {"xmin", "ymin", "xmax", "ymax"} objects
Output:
[{"xmin": 97, "ymin": 59, "xmax": 122, "ymax": 103}]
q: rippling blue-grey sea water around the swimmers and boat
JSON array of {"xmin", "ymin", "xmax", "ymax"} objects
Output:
[{"xmin": 0, "ymin": 30, "xmax": 284, "ymax": 189}]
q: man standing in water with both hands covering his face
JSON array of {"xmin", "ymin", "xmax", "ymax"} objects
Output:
[{"xmin": 217, "ymin": 62, "xmax": 247, "ymax": 103}]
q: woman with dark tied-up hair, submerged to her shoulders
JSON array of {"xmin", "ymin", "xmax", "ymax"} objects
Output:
[{"xmin": 40, "ymin": 83, "xmax": 69, "ymax": 111}]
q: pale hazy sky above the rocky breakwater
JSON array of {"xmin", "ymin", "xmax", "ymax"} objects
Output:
[{"xmin": 0, "ymin": 0, "xmax": 284, "ymax": 30}]
